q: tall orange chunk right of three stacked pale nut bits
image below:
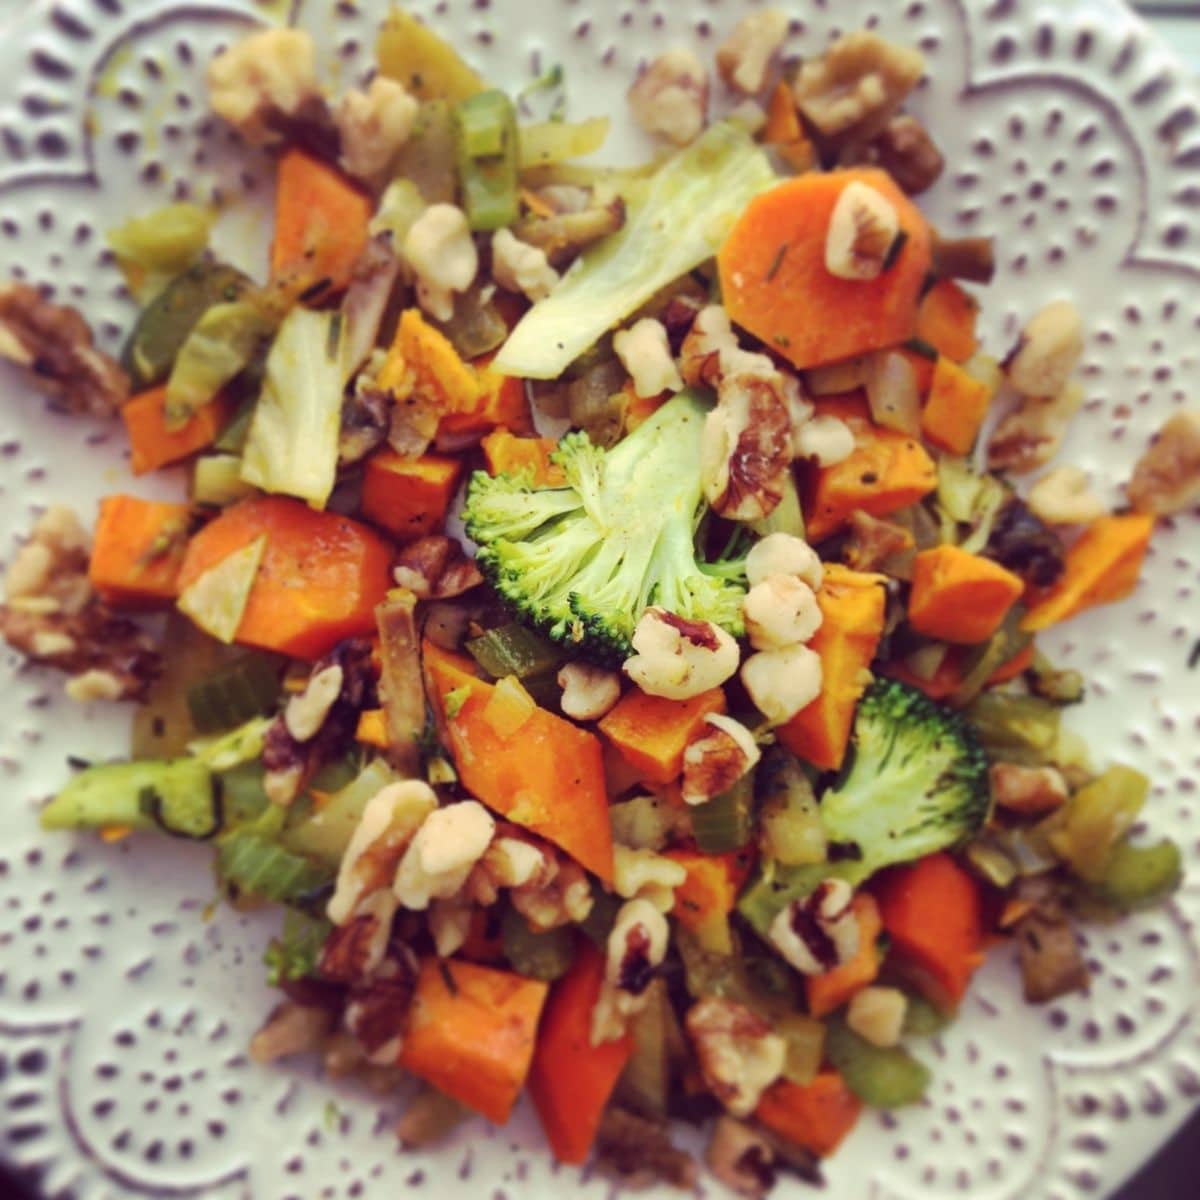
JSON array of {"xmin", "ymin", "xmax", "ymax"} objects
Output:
[{"xmin": 776, "ymin": 563, "xmax": 887, "ymax": 770}]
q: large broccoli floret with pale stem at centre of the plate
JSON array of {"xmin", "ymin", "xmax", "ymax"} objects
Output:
[{"xmin": 463, "ymin": 391, "xmax": 745, "ymax": 662}]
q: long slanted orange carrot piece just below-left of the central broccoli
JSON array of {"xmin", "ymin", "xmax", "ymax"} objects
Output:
[{"xmin": 424, "ymin": 642, "xmax": 612, "ymax": 883}]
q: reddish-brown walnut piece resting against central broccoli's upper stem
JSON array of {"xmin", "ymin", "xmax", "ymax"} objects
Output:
[{"xmin": 700, "ymin": 373, "xmax": 792, "ymax": 521}]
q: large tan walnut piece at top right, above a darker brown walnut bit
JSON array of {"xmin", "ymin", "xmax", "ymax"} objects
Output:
[{"xmin": 792, "ymin": 30, "xmax": 925, "ymax": 145}]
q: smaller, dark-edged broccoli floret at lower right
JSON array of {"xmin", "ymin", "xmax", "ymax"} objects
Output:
[{"xmin": 821, "ymin": 679, "xmax": 991, "ymax": 878}]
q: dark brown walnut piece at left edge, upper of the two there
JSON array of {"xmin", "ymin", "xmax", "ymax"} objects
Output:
[{"xmin": 0, "ymin": 283, "xmax": 130, "ymax": 416}]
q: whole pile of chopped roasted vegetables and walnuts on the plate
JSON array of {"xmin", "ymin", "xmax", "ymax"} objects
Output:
[{"xmin": 0, "ymin": 11, "xmax": 1200, "ymax": 1195}]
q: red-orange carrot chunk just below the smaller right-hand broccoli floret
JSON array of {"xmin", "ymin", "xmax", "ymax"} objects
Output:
[{"xmin": 872, "ymin": 853, "xmax": 983, "ymax": 1009}]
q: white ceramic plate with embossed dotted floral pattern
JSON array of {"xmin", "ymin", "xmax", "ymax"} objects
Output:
[{"xmin": 0, "ymin": 0, "xmax": 1200, "ymax": 1200}]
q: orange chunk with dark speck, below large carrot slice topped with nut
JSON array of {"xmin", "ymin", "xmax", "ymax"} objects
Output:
[{"xmin": 804, "ymin": 394, "xmax": 937, "ymax": 542}]
